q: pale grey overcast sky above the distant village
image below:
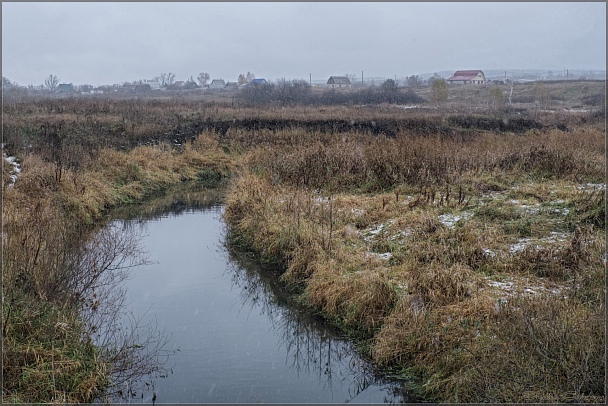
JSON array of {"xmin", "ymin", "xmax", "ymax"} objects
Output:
[{"xmin": 2, "ymin": 1, "xmax": 606, "ymax": 85}]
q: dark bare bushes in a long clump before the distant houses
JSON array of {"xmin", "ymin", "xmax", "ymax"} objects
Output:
[{"xmin": 235, "ymin": 79, "xmax": 425, "ymax": 106}]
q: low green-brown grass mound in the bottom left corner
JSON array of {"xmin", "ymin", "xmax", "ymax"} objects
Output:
[{"xmin": 2, "ymin": 293, "xmax": 109, "ymax": 403}]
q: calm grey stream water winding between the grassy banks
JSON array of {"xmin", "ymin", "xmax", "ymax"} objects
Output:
[{"xmin": 115, "ymin": 193, "xmax": 408, "ymax": 403}]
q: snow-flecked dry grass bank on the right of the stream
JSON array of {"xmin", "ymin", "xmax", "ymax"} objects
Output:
[{"xmin": 225, "ymin": 122, "xmax": 606, "ymax": 402}]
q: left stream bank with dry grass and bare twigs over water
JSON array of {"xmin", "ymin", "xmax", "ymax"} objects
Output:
[{"xmin": 2, "ymin": 135, "xmax": 235, "ymax": 403}]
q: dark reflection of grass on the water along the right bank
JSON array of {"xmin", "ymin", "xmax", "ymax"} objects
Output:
[{"xmin": 226, "ymin": 252, "xmax": 411, "ymax": 403}]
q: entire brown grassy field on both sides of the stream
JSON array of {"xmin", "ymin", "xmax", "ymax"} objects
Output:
[{"xmin": 2, "ymin": 82, "xmax": 606, "ymax": 402}]
